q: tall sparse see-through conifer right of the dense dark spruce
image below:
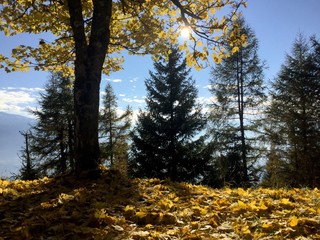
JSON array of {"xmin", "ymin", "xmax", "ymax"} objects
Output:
[{"xmin": 206, "ymin": 19, "xmax": 266, "ymax": 186}]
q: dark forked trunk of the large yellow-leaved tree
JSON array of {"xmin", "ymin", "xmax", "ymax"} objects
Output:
[{"xmin": 68, "ymin": 0, "xmax": 112, "ymax": 173}]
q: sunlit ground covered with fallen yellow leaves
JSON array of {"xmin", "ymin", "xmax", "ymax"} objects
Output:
[{"xmin": 0, "ymin": 171, "xmax": 320, "ymax": 240}]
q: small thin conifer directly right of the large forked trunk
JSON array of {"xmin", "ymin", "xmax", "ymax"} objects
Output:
[{"xmin": 99, "ymin": 84, "xmax": 132, "ymax": 174}]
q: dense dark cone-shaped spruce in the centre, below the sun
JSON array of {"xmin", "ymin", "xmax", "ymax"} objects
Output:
[{"xmin": 130, "ymin": 47, "xmax": 209, "ymax": 181}]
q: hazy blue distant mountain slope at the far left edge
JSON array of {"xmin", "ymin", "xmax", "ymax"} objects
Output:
[{"xmin": 0, "ymin": 112, "xmax": 34, "ymax": 177}]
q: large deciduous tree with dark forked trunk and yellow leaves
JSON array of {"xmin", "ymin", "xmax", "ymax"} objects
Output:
[{"xmin": 0, "ymin": 0, "xmax": 245, "ymax": 174}]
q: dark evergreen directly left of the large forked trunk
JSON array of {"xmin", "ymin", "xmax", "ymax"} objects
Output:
[{"xmin": 30, "ymin": 73, "xmax": 74, "ymax": 175}]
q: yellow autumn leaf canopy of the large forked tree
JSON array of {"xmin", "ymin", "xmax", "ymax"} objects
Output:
[{"xmin": 0, "ymin": 0, "xmax": 246, "ymax": 74}]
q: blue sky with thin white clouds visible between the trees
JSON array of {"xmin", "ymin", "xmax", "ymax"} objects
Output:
[{"xmin": 0, "ymin": 0, "xmax": 320, "ymax": 115}]
